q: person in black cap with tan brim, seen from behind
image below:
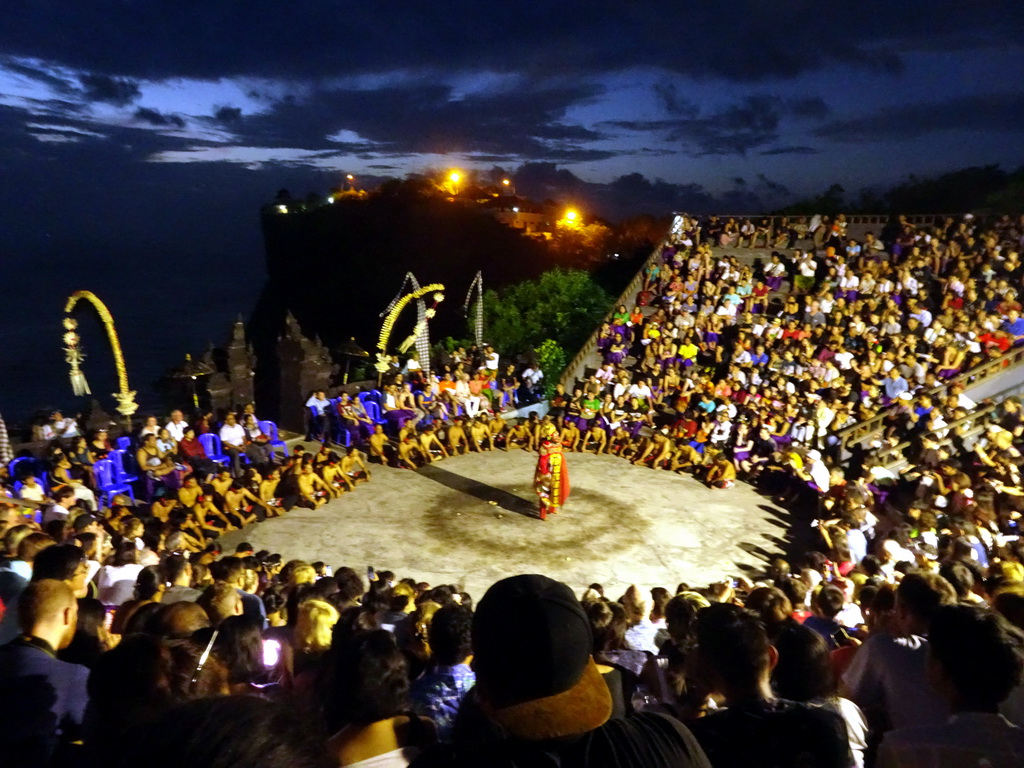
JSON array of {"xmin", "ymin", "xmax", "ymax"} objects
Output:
[{"xmin": 413, "ymin": 574, "xmax": 710, "ymax": 768}]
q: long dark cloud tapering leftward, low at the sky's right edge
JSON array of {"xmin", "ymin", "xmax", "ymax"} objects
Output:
[{"xmin": 812, "ymin": 93, "xmax": 1024, "ymax": 142}]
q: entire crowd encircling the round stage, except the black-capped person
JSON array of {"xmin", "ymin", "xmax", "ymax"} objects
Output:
[{"xmin": 6, "ymin": 211, "xmax": 1024, "ymax": 768}]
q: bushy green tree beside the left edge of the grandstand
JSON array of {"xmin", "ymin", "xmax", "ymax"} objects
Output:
[{"xmin": 483, "ymin": 268, "xmax": 612, "ymax": 354}]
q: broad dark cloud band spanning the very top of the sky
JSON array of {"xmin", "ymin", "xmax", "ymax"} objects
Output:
[{"xmin": 0, "ymin": 0, "xmax": 1024, "ymax": 82}]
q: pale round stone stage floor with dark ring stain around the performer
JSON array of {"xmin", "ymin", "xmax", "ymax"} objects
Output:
[{"xmin": 222, "ymin": 450, "xmax": 790, "ymax": 598}]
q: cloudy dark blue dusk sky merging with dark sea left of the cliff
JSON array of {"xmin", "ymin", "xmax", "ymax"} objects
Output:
[{"xmin": 0, "ymin": 0, "xmax": 1024, "ymax": 421}]
